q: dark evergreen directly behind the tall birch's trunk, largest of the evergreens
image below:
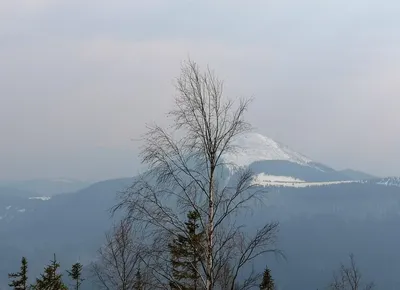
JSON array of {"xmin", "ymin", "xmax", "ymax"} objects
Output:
[{"xmin": 169, "ymin": 211, "xmax": 204, "ymax": 290}]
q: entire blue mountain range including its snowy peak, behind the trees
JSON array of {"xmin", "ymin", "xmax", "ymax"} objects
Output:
[{"xmin": 0, "ymin": 133, "xmax": 400, "ymax": 290}]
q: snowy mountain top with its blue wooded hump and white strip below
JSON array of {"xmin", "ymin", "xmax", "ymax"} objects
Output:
[{"xmin": 223, "ymin": 133, "xmax": 400, "ymax": 187}]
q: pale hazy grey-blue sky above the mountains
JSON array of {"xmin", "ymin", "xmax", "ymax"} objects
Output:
[{"xmin": 0, "ymin": 0, "xmax": 400, "ymax": 179}]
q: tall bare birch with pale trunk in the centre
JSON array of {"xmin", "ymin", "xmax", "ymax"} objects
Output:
[{"xmin": 114, "ymin": 60, "xmax": 278, "ymax": 290}]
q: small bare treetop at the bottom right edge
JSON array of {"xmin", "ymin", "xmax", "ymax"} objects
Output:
[{"xmin": 330, "ymin": 254, "xmax": 374, "ymax": 290}]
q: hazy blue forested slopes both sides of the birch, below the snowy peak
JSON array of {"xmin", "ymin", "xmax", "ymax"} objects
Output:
[{"xmin": 0, "ymin": 179, "xmax": 400, "ymax": 290}]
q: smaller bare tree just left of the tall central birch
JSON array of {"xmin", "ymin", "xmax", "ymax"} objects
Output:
[{"xmin": 92, "ymin": 220, "xmax": 148, "ymax": 290}]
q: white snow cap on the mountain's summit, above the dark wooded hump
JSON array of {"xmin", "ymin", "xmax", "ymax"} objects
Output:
[{"xmin": 224, "ymin": 133, "xmax": 312, "ymax": 167}]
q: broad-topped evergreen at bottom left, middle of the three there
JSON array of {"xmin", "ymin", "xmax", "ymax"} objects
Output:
[{"xmin": 32, "ymin": 254, "xmax": 67, "ymax": 290}]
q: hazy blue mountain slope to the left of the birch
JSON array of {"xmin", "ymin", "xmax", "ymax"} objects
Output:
[{"xmin": 0, "ymin": 178, "xmax": 132, "ymax": 284}]
